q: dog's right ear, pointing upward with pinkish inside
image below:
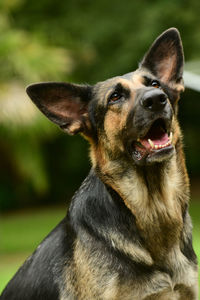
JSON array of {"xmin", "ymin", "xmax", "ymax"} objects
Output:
[{"xmin": 141, "ymin": 28, "xmax": 184, "ymax": 91}]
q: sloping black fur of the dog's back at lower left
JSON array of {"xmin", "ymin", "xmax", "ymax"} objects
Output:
[{"xmin": 0, "ymin": 218, "xmax": 73, "ymax": 300}]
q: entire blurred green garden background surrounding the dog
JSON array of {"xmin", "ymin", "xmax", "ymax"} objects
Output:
[{"xmin": 0, "ymin": 0, "xmax": 200, "ymax": 296}]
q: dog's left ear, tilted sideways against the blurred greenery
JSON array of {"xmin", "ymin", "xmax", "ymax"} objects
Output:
[{"xmin": 26, "ymin": 82, "xmax": 92, "ymax": 135}]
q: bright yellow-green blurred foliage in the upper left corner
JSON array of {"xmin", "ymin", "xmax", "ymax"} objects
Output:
[{"xmin": 0, "ymin": 0, "xmax": 72, "ymax": 83}]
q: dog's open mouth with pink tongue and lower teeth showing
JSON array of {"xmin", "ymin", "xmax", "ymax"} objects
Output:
[{"xmin": 133, "ymin": 119, "xmax": 173, "ymax": 160}]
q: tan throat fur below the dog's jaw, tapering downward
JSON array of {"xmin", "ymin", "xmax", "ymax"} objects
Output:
[{"xmin": 94, "ymin": 157, "xmax": 182, "ymax": 256}]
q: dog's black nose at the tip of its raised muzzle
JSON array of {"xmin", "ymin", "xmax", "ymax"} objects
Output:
[{"xmin": 141, "ymin": 89, "xmax": 167, "ymax": 111}]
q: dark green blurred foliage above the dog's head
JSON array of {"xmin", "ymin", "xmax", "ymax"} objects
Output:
[{"xmin": 8, "ymin": 0, "xmax": 200, "ymax": 82}]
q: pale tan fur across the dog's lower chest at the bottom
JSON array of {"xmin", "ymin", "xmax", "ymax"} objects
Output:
[{"xmin": 61, "ymin": 247, "xmax": 198, "ymax": 300}]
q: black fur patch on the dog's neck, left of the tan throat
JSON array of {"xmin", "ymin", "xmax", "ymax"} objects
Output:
[{"xmin": 70, "ymin": 170, "xmax": 141, "ymax": 242}]
